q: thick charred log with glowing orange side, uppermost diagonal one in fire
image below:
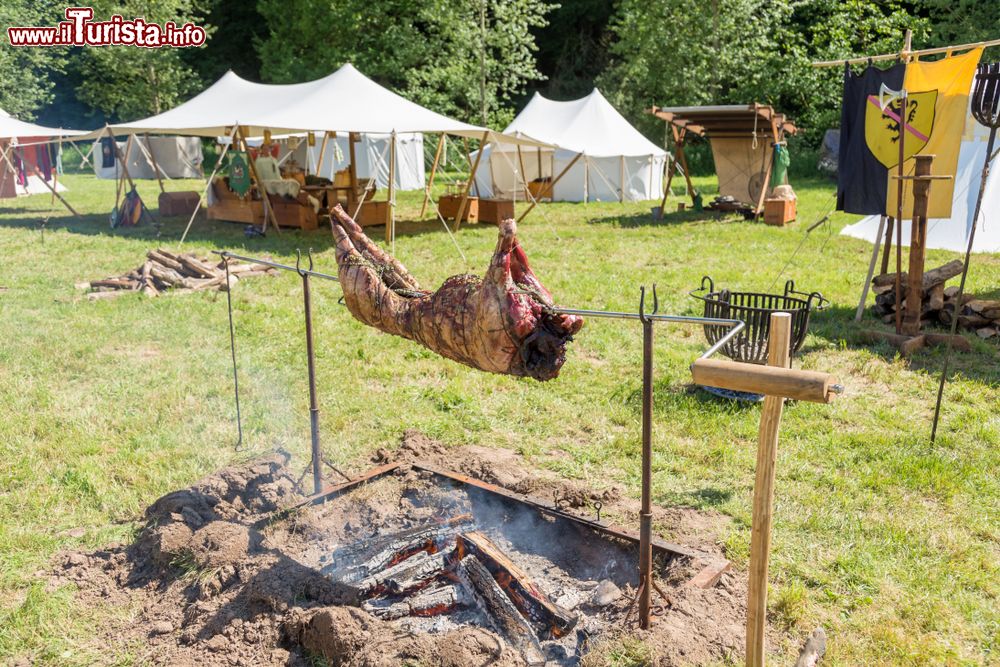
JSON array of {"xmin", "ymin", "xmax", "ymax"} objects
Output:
[{"xmin": 455, "ymin": 531, "xmax": 580, "ymax": 639}]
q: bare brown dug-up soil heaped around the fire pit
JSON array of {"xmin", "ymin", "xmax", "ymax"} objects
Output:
[{"xmin": 50, "ymin": 432, "xmax": 746, "ymax": 667}]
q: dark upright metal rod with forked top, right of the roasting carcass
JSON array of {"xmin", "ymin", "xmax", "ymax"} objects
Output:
[{"xmin": 639, "ymin": 290, "xmax": 653, "ymax": 630}]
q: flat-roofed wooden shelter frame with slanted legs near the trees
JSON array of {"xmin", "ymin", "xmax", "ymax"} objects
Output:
[{"xmin": 649, "ymin": 102, "xmax": 798, "ymax": 216}]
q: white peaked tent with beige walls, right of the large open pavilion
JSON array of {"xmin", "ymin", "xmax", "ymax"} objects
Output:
[{"xmin": 476, "ymin": 88, "xmax": 667, "ymax": 201}]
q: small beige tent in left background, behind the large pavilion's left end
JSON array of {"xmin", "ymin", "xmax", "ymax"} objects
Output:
[{"xmin": 92, "ymin": 136, "xmax": 205, "ymax": 179}]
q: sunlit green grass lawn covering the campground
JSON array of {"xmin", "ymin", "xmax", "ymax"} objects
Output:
[{"xmin": 0, "ymin": 175, "xmax": 1000, "ymax": 665}]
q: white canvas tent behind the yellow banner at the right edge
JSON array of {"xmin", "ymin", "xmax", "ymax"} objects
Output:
[{"xmin": 840, "ymin": 114, "xmax": 1000, "ymax": 252}]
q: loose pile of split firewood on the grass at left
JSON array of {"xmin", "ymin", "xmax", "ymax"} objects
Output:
[{"xmin": 77, "ymin": 248, "xmax": 277, "ymax": 301}]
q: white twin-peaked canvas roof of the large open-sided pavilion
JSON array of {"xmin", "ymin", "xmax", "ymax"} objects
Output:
[{"xmin": 79, "ymin": 64, "xmax": 542, "ymax": 240}]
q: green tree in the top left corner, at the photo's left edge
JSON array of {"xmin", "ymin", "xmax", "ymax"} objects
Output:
[{"xmin": 0, "ymin": 0, "xmax": 67, "ymax": 120}]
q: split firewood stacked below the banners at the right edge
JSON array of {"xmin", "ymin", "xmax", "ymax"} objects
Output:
[{"xmin": 872, "ymin": 259, "xmax": 1000, "ymax": 338}]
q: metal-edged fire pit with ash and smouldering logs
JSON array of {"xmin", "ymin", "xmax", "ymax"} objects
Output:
[{"xmin": 274, "ymin": 464, "xmax": 728, "ymax": 665}]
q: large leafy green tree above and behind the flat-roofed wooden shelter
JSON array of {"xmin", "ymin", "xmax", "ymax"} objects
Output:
[{"xmin": 599, "ymin": 0, "xmax": 930, "ymax": 145}]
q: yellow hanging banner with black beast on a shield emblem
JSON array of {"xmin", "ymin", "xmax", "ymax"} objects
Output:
[{"xmin": 886, "ymin": 48, "xmax": 983, "ymax": 220}]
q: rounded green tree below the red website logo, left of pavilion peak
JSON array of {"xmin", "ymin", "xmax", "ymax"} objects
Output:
[{"xmin": 75, "ymin": 0, "xmax": 212, "ymax": 120}]
